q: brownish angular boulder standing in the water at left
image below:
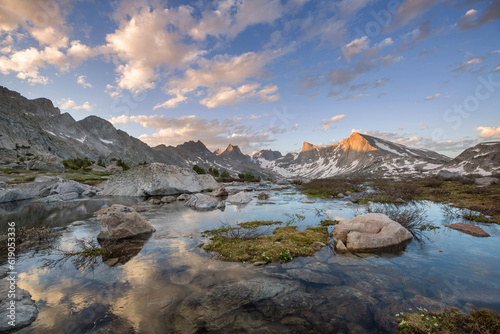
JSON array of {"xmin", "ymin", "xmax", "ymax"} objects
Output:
[{"xmin": 97, "ymin": 204, "xmax": 156, "ymax": 240}]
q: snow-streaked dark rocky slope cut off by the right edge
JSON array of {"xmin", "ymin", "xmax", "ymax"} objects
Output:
[{"xmin": 439, "ymin": 141, "xmax": 500, "ymax": 176}]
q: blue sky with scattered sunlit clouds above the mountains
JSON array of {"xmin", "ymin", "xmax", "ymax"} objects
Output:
[{"xmin": 0, "ymin": 0, "xmax": 500, "ymax": 157}]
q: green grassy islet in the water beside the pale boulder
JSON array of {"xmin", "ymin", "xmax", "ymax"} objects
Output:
[{"xmin": 204, "ymin": 226, "xmax": 330, "ymax": 263}]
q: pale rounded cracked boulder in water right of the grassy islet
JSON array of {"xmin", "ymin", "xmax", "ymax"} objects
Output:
[{"xmin": 334, "ymin": 213, "xmax": 413, "ymax": 252}]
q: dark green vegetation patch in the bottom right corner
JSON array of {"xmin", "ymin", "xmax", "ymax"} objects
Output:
[{"xmin": 396, "ymin": 308, "xmax": 500, "ymax": 334}]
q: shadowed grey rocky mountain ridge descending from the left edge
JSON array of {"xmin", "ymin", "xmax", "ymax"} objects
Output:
[{"xmin": 0, "ymin": 86, "xmax": 272, "ymax": 177}]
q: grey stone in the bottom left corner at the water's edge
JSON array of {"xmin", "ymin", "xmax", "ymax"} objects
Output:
[{"xmin": 0, "ymin": 278, "xmax": 38, "ymax": 333}]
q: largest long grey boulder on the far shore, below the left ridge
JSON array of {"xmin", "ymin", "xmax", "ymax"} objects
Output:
[{"xmin": 103, "ymin": 163, "xmax": 217, "ymax": 197}]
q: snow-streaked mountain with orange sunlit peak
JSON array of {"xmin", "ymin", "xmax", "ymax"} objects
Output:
[{"xmin": 253, "ymin": 132, "xmax": 451, "ymax": 178}]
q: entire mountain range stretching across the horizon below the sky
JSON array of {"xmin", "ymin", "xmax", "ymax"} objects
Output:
[{"xmin": 0, "ymin": 86, "xmax": 500, "ymax": 178}]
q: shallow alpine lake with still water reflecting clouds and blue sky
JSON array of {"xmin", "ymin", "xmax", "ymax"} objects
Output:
[{"xmin": 0, "ymin": 187, "xmax": 500, "ymax": 333}]
